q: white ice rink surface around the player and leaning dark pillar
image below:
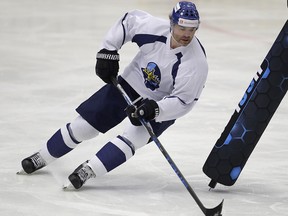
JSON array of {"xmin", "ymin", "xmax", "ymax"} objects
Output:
[{"xmin": 0, "ymin": 0, "xmax": 288, "ymax": 216}]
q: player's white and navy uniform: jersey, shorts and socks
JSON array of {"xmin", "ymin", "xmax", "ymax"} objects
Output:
[{"xmin": 40, "ymin": 10, "xmax": 208, "ymax": 179}]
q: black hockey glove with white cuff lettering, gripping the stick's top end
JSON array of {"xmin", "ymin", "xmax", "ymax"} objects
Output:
[{"xmin": 95, "ymin": 49, "xmax": 119, "ymax": 83}]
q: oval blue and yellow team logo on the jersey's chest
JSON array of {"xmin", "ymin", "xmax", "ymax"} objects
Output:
[{"xmin": 141, "ymin": 62, "xmax": 161, "ymax": 91}]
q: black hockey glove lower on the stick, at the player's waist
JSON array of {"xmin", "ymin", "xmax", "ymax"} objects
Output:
[{"xmin": 125, "ymin": 99, "xmax": 159, "ymax": 126}]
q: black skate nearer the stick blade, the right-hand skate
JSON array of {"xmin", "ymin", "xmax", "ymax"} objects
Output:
[{"xmin": 68, "ymin": 161, "xmax": 96, "ymax": 189}]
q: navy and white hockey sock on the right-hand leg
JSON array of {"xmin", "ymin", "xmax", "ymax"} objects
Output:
[{"xmin": 89, "ymin": 136, "xmax": 135, "ymax": 176}]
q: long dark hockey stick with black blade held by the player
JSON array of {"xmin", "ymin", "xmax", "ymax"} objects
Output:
[{"xmin": 111, "ymin": 77, "xmax": 224, "ymax": 216}]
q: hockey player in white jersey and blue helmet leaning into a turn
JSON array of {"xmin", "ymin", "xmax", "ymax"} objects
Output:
[{"xmin": 22, "ymin": 1, "xmax": 208, "ymax": 189}]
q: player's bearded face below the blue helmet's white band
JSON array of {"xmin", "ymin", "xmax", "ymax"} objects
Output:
[{"xmin": 172, "ymin": 25, "xmax": 197, "ymax": 48}]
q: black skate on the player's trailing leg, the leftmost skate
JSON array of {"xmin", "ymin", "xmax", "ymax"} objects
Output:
[{"xmin": 21, "ymin": 152, "xmax": 46, "ymax": 174}]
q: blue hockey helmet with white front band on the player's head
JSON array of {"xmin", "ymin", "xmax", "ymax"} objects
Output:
[{"xmin": 171, "ymin": 1, "xmax": 200, "ymax": 28}]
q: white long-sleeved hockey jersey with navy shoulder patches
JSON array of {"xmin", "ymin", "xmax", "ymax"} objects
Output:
[{"xmin": 101, "ymin": 10, "xmax": 208, "ymax": 122}]
